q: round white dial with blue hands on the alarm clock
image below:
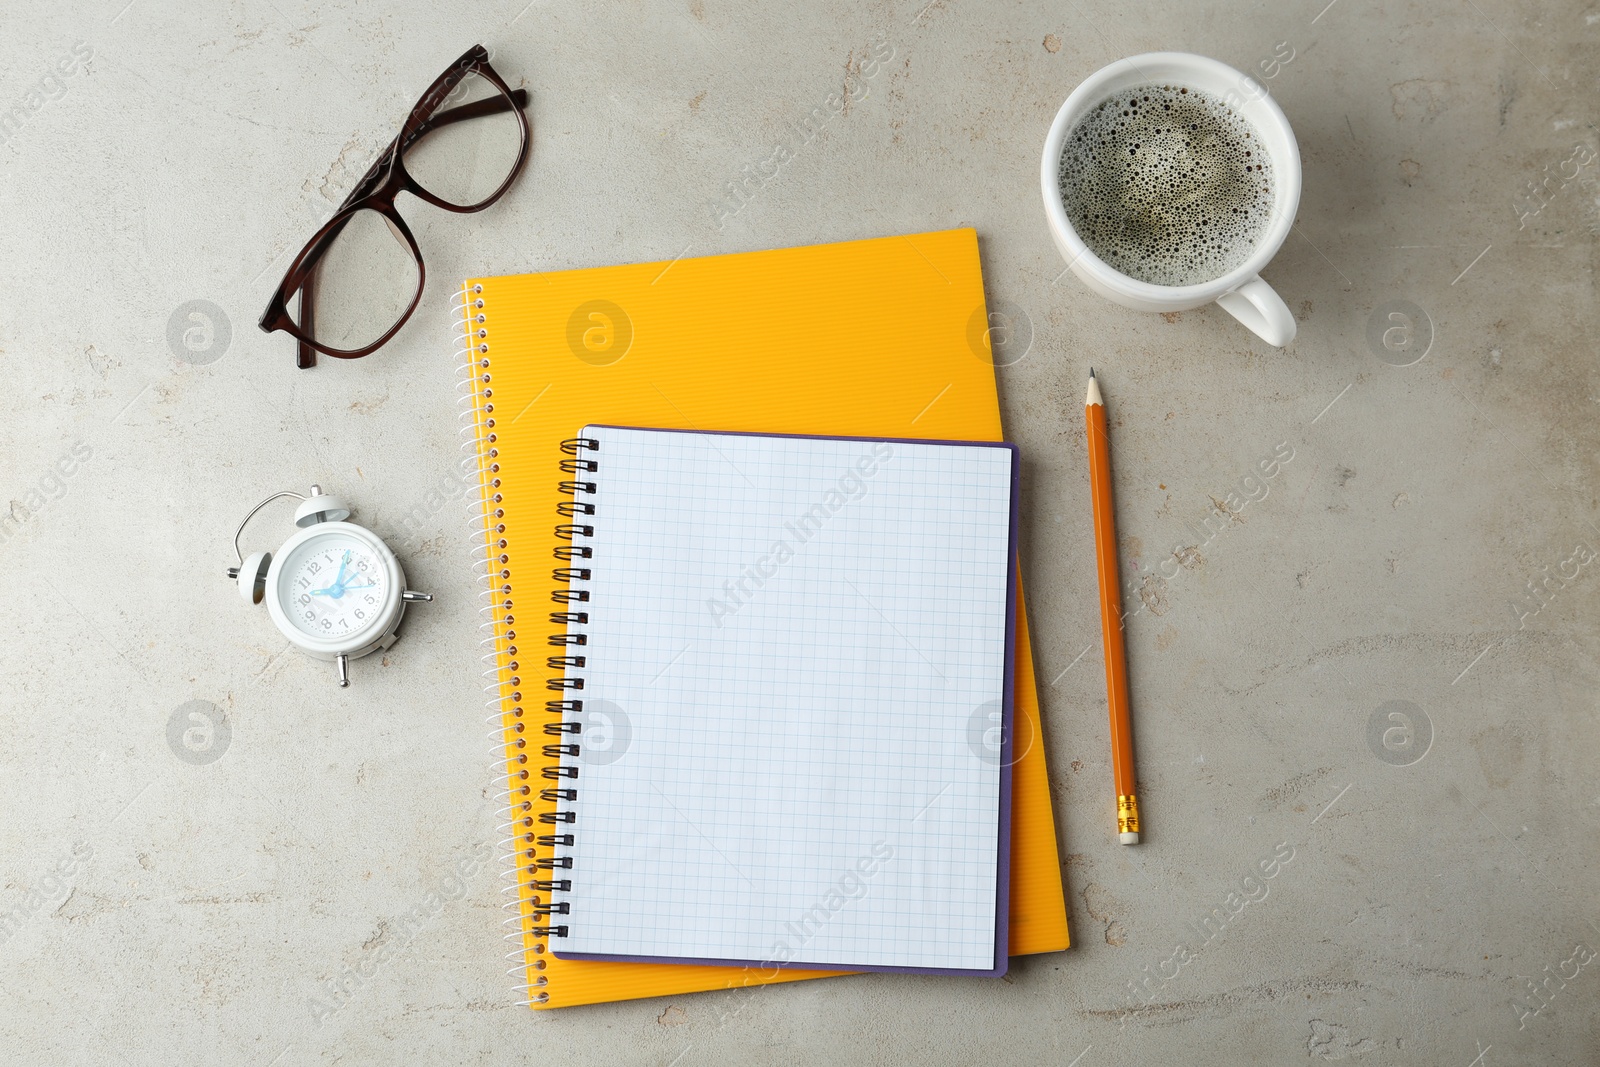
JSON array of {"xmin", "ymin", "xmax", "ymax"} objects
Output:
[{"xmin": 278, "ymin": 533, "xmax": 394, "ymax": 641}]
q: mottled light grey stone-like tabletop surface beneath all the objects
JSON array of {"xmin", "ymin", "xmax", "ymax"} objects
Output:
[{"xmin": 0, "ymin": 0, "xmax": 1600, "ymax": 1067}]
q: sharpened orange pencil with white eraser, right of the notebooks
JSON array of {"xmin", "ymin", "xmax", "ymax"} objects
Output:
[{"xmin": 1083, "ymin": 371, "xmax": 1139, "ymax": 845}]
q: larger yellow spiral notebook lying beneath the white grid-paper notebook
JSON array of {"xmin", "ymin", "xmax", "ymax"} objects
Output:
[{"xmin": 454, "ymin": 229, "xmax": 1069, "ymax": 1008}]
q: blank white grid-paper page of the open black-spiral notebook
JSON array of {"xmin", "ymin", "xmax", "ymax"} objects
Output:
[{"xmin": 552, "ymin": 427, "xmax": 1013, "ymax": 971}]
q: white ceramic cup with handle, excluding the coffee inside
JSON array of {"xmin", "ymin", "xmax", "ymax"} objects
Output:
[{"xmin": 1040, "ymin": 51, "xmax": 1301, "ymax": 349}]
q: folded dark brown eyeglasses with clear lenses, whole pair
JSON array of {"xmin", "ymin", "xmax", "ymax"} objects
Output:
[{"xmin": 261, "ymin": 45, "xmax": 533, "ymax": 368}]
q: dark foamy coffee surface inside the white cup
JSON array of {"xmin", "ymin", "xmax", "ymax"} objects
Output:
[{"xmin": 1059, "ymin": 85, "xmax": 1274, "ymax": 285}]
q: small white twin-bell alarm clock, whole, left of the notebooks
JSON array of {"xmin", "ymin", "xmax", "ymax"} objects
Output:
[{"xmin": 227, "ymin": 485, "xmax": 434, "ymax": 686}]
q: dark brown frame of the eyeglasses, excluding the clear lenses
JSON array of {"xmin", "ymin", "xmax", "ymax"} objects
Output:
[{"xmin": 259, "ymin": 45, "xmax": 533, "ymax": 370}]
